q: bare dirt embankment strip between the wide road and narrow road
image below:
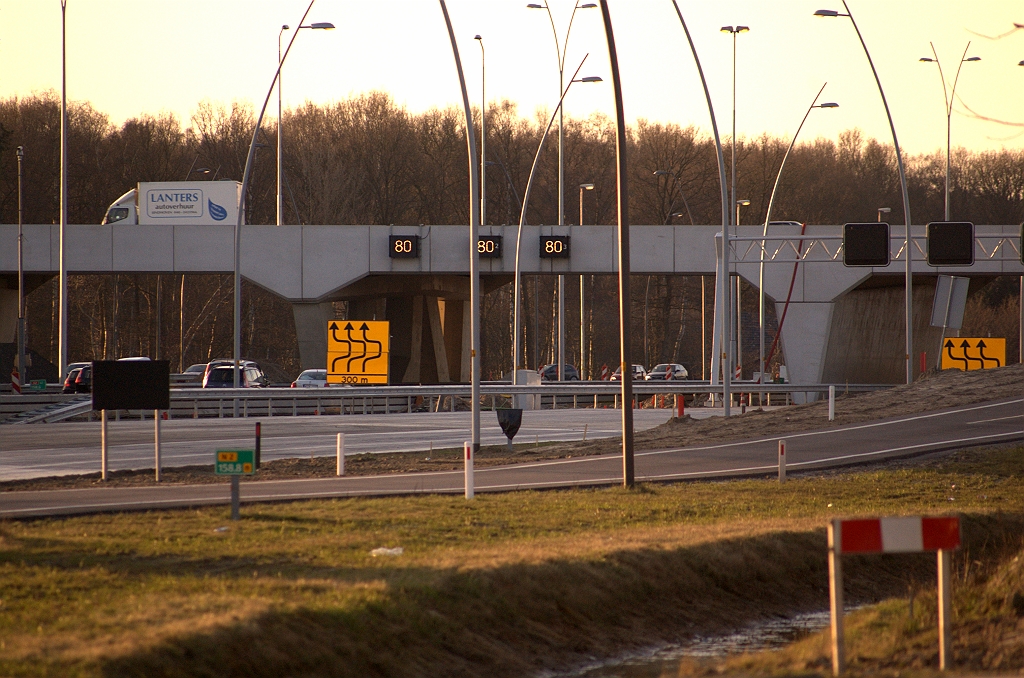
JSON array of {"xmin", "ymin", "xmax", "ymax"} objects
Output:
[{"xmin": 6, "ymin": 364, "xmax": 1024, "ymax": 492}]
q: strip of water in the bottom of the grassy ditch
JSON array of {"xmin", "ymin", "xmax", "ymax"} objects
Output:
[{"xmin": 563, "ymin": 610, "xmax": 828, "ymax": 678}]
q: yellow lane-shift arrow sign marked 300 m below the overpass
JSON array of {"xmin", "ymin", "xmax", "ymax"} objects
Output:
[{"xmin": 327, "ymin": 321, "xmax": 390, "ymax": 385}]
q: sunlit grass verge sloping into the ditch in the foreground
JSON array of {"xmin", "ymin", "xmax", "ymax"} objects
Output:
[{"xmin": 0, "ymin": 447, "xmax": 1024, "ymax": 676}]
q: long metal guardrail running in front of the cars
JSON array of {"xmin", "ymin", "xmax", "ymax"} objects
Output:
[{"xmin": 0, "ymin": 381, "xmax": 892, "ymax": 423}]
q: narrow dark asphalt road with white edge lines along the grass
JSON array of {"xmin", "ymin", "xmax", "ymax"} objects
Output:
[{"xmin": 0, "ymin": 398, "xmax": 1024, "ymax": 517}]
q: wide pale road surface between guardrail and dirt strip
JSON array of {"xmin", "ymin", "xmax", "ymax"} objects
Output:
[{"xmin": 0, "ymin": 408, "xmax": 684, "ymax": 480}]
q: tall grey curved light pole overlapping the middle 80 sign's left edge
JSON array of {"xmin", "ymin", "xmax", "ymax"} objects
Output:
[{"xmin": 437, "ymin": 0, "xmax": 482, "ymax": 458}]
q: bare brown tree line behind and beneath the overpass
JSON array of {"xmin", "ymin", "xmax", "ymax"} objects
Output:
[{"xmin": 0, "ymin": 91, "xmax": 1024, "ymax": 378}]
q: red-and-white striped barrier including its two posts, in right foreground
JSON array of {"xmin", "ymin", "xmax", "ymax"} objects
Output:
[{"xmin": 828, "ymin": 516, "xmax": 961, "ymax": 676}]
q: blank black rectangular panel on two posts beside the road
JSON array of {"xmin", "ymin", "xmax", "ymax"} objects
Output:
[{"xmin": 92, "ymin": 361, "xmax": 171, "ymax": 412}]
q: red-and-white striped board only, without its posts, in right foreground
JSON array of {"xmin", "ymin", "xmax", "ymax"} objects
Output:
[{"xmin": 837, "ymin": 516, "xmax": 961, "ymax": 553}]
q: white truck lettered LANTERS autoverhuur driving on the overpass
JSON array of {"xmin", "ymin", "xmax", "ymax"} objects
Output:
[{"xmin": 103, "ymin": 181, "xmax": 245, "ymax": 226}]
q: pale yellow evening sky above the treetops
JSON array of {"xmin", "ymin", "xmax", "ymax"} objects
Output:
[{"xmin": 0, "ymin": 0, "xmax": 1024, "ymax": 154}]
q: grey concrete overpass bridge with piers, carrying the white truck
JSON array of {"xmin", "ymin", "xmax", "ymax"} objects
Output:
[{"xmin": 0, "ymin": 222, "xmax": 1024, "ymax": 383}]
